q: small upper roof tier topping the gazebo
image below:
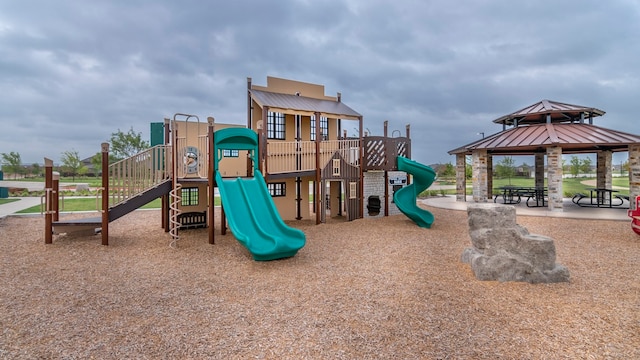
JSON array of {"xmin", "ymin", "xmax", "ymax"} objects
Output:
[{"xmin": 493, "ymin": 100, "xmax": 605, "ymax": 126}]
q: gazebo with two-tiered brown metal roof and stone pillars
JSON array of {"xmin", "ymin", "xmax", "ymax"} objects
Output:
[{"xmin": 449, "ymin": 100, "xmax": 640, "ymax": 211}]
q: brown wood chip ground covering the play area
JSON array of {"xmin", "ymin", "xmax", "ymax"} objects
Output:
[{"xmin": 0, "ymin": 208, "xmax": 640, "ymax": 359}]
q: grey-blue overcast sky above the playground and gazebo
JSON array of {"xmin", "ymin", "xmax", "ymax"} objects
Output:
[{"xmin": 0, "ymin": 0, "xmax": 640, "ymax": 164}]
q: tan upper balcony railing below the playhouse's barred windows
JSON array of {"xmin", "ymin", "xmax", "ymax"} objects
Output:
[{"xmin": 267, "ymin": 140, "xmax": 360, "ymax": 174}]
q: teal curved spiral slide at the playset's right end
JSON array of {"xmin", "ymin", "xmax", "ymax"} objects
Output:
[{"xmin": 393, "ymin": 156, "xmax": 436, "ymax": 228}]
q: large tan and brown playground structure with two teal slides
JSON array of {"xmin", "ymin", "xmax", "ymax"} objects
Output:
[{"xmin": 45, "ymin": 78, "xmax": 435, "ymax": 260}]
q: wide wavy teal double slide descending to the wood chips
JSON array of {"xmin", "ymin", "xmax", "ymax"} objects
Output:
[{"xmin": 216, "ymin": 170, "xmax": 306, "ymax": 261}]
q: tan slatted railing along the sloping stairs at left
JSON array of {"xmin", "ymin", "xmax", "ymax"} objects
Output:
[{"xmin": 108, "ymin": 145, "xmax": 171, "ymax": 206}]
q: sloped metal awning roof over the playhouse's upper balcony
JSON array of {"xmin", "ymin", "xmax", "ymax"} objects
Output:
[{"xmin": 249, "ymin": 89, "xmax": 362, "ymax": 120}]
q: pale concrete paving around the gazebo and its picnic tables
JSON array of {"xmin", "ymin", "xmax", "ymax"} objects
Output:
[{"xmin": 418, "ymin": 195, "xmax": 631, "ymax": 221}]
